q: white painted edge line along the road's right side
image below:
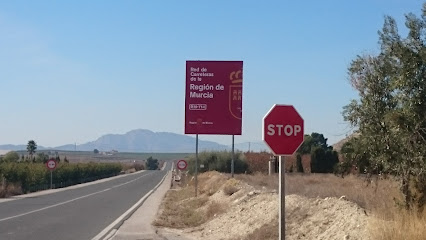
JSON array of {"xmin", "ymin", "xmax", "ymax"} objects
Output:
[{"xmin": 92, "ymin": 171, "xmax": 170, "ymax": 240}]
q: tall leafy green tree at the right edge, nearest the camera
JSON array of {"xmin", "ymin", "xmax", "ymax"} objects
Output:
[{"xmin": 343, "ymin": 3, "xmax": 426, "ymax": 210}]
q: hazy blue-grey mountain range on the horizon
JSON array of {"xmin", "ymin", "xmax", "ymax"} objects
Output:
[{"xmin": 0, "ymin": 129, "xmax": 267, "ymax": 153}]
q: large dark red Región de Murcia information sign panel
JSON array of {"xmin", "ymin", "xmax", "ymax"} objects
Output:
[{"xmin": 185, "ymin": 61, "xmax": 243, "ymax": 135}]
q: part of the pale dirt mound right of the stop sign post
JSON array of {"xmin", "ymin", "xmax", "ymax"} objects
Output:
[{"xmin": 286, "ymin": 195, "xmax": 369, "ymax": 240}]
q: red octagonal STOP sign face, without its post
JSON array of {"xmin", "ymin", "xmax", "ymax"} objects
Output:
[{"xmin": 263, "ymin": 104, "xmax": 304, "ymax": 155}]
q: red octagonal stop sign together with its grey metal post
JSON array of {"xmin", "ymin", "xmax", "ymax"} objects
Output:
[{"xmin": 262, "ymin": 104, "xmax": 304, "ymax": 240}]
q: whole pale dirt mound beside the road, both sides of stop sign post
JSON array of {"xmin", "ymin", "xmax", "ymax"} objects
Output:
[{"xmin": 155, "ymin": 172, "xmax": 369, "ymax": 240}]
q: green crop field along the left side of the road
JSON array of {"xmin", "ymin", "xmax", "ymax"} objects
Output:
[{"xmin": 0, "ymin": 151, "xmax": 190, "ymax": 198}]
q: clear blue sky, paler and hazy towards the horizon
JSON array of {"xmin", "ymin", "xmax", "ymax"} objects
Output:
[{"xmin": 0, "ymin": 0, "xmax": 422, "ymax": 147}]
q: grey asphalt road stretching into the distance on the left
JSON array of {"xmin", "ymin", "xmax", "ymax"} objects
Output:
[{"xmin": 0, "ymin": 162, "xmax": 171, "ymax": 240}]
